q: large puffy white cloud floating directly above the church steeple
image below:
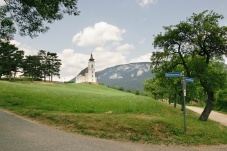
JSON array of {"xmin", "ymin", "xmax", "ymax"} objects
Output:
[{"xmin": 72, "ymin": 22, "xmax": 125, "ymax": 47}]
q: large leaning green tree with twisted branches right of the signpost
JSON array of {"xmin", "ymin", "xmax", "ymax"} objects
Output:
[{"xmin": 151, "ymin": 11, "xmax": 227, "ymax": 121}]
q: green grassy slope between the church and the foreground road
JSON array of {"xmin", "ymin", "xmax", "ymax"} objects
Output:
[{"xmin": 0, "ymin": 81, "xmax": 227, "ymax": 145}]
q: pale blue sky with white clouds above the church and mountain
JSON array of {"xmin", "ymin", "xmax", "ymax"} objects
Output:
[{"xmin": 0, "ymin": 0, "xmax": 227, "ymax": 81}]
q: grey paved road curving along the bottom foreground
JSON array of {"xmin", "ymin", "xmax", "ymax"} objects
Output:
[{"xmin": 0, "ymin": 110, "xmax": 227, "ymax": 151}]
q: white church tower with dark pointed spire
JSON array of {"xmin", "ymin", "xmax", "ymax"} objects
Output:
[{"xmin": 88, "ymin": 54, "xmax": 96, "ymax": 82}]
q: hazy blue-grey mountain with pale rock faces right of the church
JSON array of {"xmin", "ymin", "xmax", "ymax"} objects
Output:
[{"xmin": 96, "ymin": 62, "xmax": 153, "ymax": 91}]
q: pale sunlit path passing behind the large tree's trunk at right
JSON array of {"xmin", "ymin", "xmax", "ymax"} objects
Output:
[{"xmin": 187, "ymin": 106, "xmax": 227, "ymax": 126}]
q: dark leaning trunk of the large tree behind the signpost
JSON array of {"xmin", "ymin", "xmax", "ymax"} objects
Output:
[{"xmin": 199, "ymin": 91, "xmax": 215, "ymax": 121}]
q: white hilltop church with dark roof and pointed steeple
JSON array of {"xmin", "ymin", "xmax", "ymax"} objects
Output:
[{"xmin": 75, "ymin": 54, "xmax": 96, "ymax": 83}]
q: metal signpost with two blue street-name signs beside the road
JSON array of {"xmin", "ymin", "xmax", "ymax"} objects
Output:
[{"xmin": 165, "ymin": 71, "xmax": 194, "ymax": 134}]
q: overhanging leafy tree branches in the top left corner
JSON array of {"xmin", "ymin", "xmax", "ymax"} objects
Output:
[{"xmin": 0, "ymin": 0, "xmax": 79, "ymax": 37}]
